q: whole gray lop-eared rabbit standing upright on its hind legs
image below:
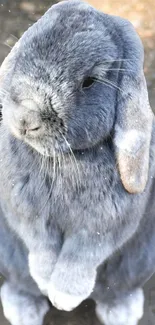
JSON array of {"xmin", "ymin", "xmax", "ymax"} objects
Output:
[{"xmin": 0, "ymin": 1, "xmax": 155, "ymax": 325}]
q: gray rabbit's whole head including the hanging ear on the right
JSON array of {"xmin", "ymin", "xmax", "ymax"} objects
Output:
[{"xmin": 0, "ymin": 0, "xmax": 152, "ymax": 193}]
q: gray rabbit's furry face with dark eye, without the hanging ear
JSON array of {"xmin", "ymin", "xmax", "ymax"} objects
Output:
[{"xmin": 3, "ymin": 2, "xmax": 118, "ymax": 156}]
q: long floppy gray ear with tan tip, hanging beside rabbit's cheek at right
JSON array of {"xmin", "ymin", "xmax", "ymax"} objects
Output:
[{"xmin": 114, "ymin": 17, "xmax": 153, "ymax": 193}]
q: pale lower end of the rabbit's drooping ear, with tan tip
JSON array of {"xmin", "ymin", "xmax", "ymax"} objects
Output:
[{"xmin": 115, "ymin": 126, "xmax": 151, "ymax": 194}]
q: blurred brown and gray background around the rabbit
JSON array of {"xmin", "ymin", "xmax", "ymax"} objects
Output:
[{"xmin": 0, "ymin": 0, "xmax": 155, "ymax": 325}]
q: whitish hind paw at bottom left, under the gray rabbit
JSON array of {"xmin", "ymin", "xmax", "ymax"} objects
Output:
[{"xmin": 1, "ymin": 283, "xmax": 49, "ymax": 325}]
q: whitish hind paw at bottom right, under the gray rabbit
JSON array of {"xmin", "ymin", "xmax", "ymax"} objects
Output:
[{"xmin": 96, "ymin": 289, "xmax": 144, "ymax": 325}]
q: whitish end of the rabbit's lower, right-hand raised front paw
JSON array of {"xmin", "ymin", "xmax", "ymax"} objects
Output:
[{"xmin": 48, "ymin": 268, "xmax": 95, "ymax": 311}]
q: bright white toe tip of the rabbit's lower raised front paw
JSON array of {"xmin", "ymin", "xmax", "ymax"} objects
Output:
[{"xmin": 48, "ymin": 284, "xmax": 86, "ymax": 311}]
